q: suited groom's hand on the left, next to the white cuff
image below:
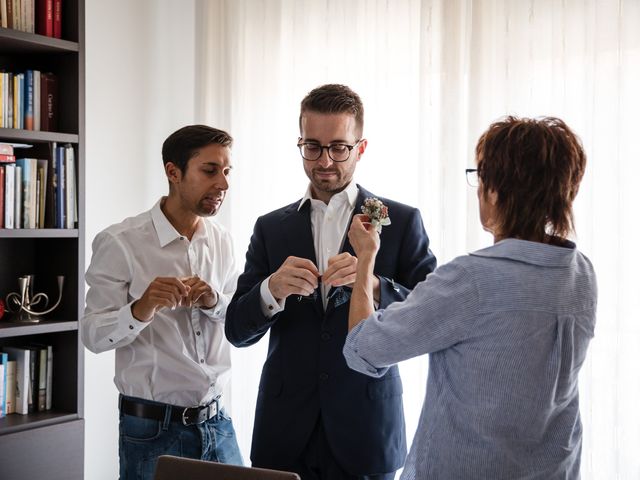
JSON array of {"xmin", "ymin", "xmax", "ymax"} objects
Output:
[{"xmin": 269, "ymin": 257, "xmax": 320, "ymax": 301}]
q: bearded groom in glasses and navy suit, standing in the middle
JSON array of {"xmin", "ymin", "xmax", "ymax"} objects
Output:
[{"xmin": 225, "ymin": 85, "xmax": 436, "ymax": 480}]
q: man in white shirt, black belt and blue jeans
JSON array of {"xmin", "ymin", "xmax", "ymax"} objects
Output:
[{"xmin": 81, "ymin": 125, "xmax": 242, "ymax": 480}]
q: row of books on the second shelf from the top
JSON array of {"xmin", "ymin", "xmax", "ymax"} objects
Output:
[{"xmin": 0, "ymin": 70, "xmax": 58, "ymax": 131}]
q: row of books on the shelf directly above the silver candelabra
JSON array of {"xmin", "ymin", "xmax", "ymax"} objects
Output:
[{"xmin": 0, "ymin": 142, "xmax": 78, "ymax": 229}]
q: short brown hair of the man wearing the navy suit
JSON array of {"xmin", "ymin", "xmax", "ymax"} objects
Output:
[{"xmin": 298, "ymin": 83, "xmax": 364, "ymax": 136}]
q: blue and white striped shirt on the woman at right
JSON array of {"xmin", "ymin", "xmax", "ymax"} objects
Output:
[{"xmin": 344, "ymin": 239, "xmax": 597, "ymax": 480}]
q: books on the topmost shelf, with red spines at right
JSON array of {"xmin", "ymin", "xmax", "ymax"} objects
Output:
[{"xmin": 0, "ymin": 0, "xmax": 62, "ymax": 38}]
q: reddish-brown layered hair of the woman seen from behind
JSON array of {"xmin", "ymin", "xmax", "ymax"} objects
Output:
[{"xmin": 476, "ymin": 116, "xmax": 586, "ymax": 242}]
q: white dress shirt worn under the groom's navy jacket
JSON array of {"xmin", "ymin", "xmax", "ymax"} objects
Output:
[{"xmin": 260, "ymin": 181, "xmax": 358, "ymax": 317}]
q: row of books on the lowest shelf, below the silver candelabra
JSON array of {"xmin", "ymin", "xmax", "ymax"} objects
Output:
[{"xmin": 0, "ymin": 344, "xmax": 53, "ymax": 417}]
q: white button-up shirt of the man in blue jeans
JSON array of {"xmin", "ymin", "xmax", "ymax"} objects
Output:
[{"xmin": 81, "ymin": 200, "xmax": 239, "ymax": 406}]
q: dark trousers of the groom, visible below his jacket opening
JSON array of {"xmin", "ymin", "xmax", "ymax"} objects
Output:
[{"xmin": 289, "ymin": 417, "xmax": 395, "ymax": 480}]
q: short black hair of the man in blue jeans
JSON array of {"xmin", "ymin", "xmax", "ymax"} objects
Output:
[{"xmin": 162, "ymin": 125, "xmax": 233, "ymax": 173}]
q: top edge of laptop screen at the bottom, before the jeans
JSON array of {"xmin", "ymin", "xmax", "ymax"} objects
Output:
[{"xmin": 154, "ymin": 455, "xmax": 300, "ymax": 480}]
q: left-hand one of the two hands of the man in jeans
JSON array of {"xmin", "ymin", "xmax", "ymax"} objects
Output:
[{"xmin": 131, "ymin": 277, "xmax": 190, "ymax": 322}]
